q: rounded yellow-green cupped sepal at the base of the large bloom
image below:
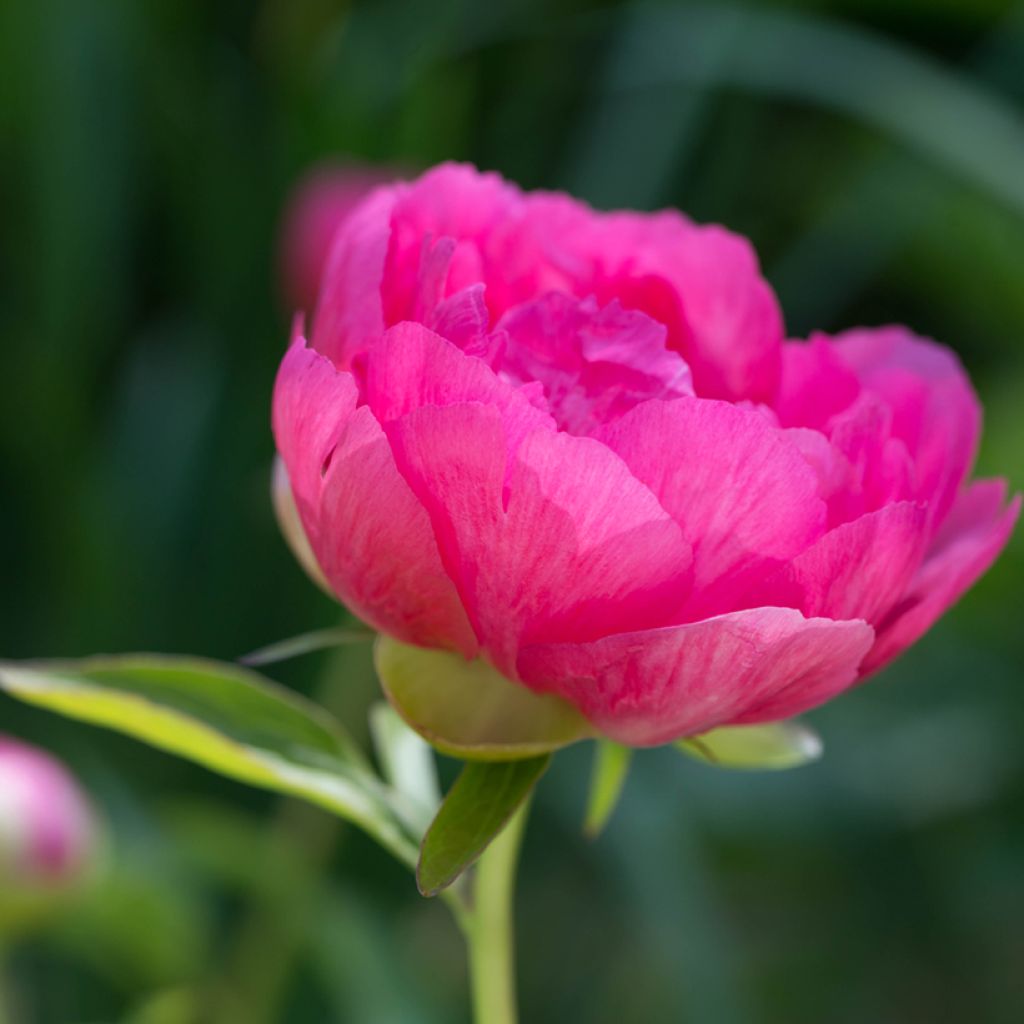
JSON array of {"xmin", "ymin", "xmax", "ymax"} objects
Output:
[{"xmin": 375, "ymin": 636, "xmax": 595, "ymax": 761}]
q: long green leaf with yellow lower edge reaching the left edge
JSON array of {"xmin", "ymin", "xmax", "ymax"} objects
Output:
[{"xmin": 0, "ymin": 654, "xmax": 416, "ymax": 864}]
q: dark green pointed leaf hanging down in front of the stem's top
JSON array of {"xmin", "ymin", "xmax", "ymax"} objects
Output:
[{"xmin": 416, "ymin": 755, "xmax": 551, "ymax": 896}]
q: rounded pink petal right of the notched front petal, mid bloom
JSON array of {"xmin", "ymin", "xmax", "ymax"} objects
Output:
[{"xmin": 598, "ymin": 398, "xmax": 825, "ymax": 614}]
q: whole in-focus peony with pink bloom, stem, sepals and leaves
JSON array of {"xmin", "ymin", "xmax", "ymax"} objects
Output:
[{"xmin": 0, "ymin": 165, "xmax": 1020, "ymax": 1024}]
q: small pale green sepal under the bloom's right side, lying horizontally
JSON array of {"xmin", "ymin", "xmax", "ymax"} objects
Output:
[{"xmin": 675, "ymin": 720, "xmax": 822, "ymax": 770}]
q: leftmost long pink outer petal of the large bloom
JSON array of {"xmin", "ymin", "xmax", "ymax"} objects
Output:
[{"xmin": 273, "ymin": 339, "xmax": 477, "ymax": 657}]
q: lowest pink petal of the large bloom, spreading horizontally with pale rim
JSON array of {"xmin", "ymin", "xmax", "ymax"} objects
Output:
[{"xmin": 518, "ymin": 608, "xmax": 873, "ymax": 745}]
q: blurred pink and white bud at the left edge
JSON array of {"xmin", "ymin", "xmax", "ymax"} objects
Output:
[{"xmin": 0, "ymin": 737, "xmax": 94, "ymax": 891}]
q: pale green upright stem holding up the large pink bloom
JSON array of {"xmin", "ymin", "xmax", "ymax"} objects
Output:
[{"xmin": 465, "ymin": 801, "xmax": 529, "ymax": 1024}]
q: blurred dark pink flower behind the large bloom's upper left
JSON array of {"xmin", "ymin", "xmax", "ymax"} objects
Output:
[{"xmin": 281, "ymin": 161, "xmax": 395, "ymax": 310}]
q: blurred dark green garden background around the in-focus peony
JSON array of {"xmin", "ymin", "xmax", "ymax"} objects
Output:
[{"xmin": 0, "ymin": 0, "xmax": 1024, "ymax": 1024}]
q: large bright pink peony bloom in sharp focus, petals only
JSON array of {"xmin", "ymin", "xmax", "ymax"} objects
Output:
[{"xmin": 273, "ymin": 165, "xmax": 1019, "ymax": 745}]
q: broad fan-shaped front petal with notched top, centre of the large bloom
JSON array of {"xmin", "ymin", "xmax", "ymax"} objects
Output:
[{"xmin": 388, "ymin": 403, "xmax": 691, "ymax": 676}]
